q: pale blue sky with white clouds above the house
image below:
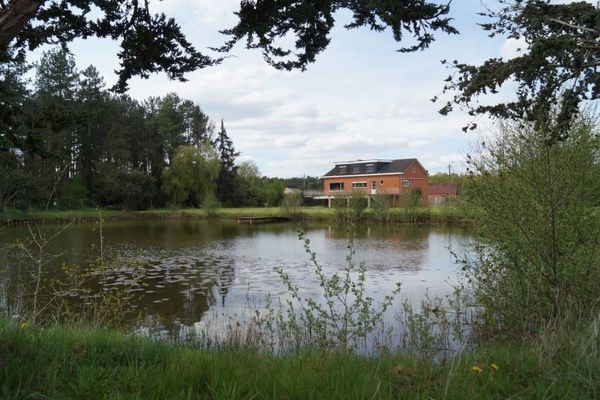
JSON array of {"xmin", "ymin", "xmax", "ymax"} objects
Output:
[{"xmin": 36, "ymin": 0, "xmax": 572, "ymax": 178}]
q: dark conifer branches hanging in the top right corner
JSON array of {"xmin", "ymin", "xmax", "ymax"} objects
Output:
[{"xmin": 441, "ymin": 0, "xmax": 600, "ymax": 141}]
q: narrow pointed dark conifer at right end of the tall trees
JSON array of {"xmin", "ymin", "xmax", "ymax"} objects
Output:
[{"xmin": 215, "ymin": 119, "xmax": 240, "ymax": 205}]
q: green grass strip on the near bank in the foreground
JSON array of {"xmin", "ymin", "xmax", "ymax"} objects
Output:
[{"xmin": 0, "ymin": 319, "xmax": 600, "ymax": 399}]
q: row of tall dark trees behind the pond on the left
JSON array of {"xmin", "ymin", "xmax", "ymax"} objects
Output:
[{"xmin": 0, "ymin": 48, "xmax": 284, "ymax": 209}]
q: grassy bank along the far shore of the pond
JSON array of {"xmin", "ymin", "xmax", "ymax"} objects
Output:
[{"xmin": 0, "ymin": 207, "xmax": 472, "ymax": 225}]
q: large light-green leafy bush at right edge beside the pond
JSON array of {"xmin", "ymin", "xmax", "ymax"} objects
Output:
[{"xmin": 463, "ymin": 119, "xmax": 600, "ymax": 333}]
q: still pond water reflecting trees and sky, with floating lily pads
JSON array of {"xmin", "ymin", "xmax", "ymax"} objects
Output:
[{"xmin": 0, "ymin": 221, "xmax": 470, "ymax": 336}]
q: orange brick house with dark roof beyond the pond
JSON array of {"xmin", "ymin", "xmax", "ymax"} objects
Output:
[{"xmin": 315, "ymin": 158, "xmax": 429, "ymax": 207}]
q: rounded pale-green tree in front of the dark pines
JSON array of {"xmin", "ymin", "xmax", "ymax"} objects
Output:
[{"xmin": 162, "ymin": 144, "xmax": 220, "ymax": 207}]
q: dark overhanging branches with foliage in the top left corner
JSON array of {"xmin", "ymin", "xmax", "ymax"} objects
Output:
[{"xmin": 0, "ymin": 0, "xmax": 219, "ymax": 91}]
